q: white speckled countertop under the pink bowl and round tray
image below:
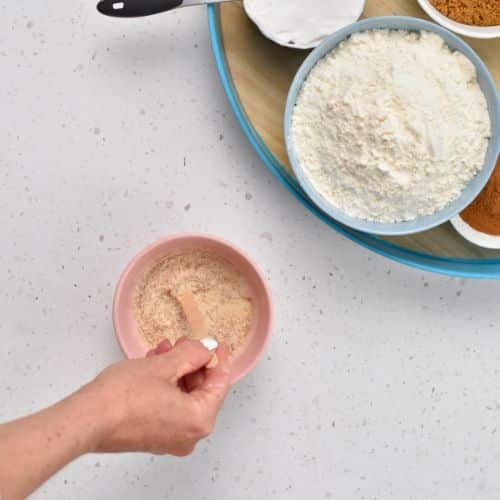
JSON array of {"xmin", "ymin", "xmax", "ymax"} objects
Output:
[{"xmin": 0, "ymin": 0, "xmax": 500, "ymax": 500}]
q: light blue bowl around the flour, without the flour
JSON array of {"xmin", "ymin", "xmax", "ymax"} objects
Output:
[{"xmin": 284, "ymin": 16, "xmax": 500, "ymax": 235}]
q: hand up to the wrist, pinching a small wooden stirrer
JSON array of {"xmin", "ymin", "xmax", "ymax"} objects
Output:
[{"xmin": 86, "ymin": 339, "xmax": 229, "ymax": 456}]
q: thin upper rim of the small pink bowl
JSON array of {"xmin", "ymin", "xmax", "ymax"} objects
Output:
[{"xmin": 112, "ymin": 232, "xmax": 274, "ymax": 385}]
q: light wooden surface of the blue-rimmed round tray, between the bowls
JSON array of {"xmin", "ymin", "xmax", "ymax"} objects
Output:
[{"xmin": 218, "ymin": 0, "xmax": 500, "ymax": 259}]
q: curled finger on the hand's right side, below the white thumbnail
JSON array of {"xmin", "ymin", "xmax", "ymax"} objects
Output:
[{"xmin": 192, "ymin": 346, "xmax": 230, "ymax": 412}]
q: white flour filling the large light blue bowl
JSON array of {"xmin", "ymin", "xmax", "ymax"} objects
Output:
[{"xmin": 291, "ymin": 30, "xmax": 490, "ymax": 222}]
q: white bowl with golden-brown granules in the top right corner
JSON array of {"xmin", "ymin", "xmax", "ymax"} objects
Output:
[{"xmin": 418, "ymin": 0, "xmax": 500, "ymax": 38}]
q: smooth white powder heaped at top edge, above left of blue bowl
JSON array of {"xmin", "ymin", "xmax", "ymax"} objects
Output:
[{"xmin": 244, "ymin": 0, "xmax": 364, "ymax": 47}]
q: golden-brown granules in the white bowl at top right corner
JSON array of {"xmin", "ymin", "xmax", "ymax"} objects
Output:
[{"xmin": 430, "ymin": 0, "xmax": 500, "ymax": 26}]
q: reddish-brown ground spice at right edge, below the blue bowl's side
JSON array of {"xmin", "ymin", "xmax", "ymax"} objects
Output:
[{"xmin": 460, "ymin": 160, "xmax": 500, "ymax": 236}]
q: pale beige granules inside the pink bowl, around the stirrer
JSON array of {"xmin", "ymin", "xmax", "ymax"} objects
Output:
[{"xmin": 134, "ymin": 250, "xmax": 253, "ymax": 353}]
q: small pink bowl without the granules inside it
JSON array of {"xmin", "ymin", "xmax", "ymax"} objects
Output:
[{"xmin": 113, "ymin": 234, "xmax": 272, "ymax": 384}]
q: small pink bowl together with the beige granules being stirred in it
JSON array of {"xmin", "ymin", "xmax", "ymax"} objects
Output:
[{"xmin": 113, "ymin": 234, "xmax": 272, "ymax": 383}]
